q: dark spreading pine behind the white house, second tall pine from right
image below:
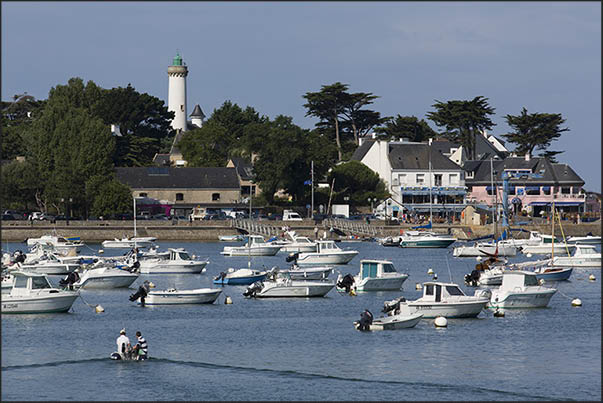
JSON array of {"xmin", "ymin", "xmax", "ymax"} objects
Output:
[{"xmin": 427, "ymin": 96, "xmax": 495, "ymax": 159}]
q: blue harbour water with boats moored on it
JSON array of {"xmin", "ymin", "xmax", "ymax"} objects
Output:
[{"xmin": 1, "ymin": 242, "xmax": 601, "ymax": 401}]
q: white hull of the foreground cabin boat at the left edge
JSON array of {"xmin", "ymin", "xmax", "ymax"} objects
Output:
[{"xmin": 2, "ymin": 292, "xmax": 78, "ymax": 314}]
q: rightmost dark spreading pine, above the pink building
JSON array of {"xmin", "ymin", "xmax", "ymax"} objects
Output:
[{"xmin": 503, "ymin": 108, "xmax": 569, "ymax": 162}]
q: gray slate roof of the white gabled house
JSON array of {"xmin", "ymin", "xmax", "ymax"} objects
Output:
[{"xmin": 389, "ymin": 143, "xmax": 462, "ymax": 170}]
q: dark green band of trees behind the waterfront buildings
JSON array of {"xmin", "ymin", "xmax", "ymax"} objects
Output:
[{"xmin": 1, "ymin": 78, "xmax": 568, "ymax": 216}]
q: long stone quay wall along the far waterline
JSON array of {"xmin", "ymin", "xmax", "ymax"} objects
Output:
[{"xmin": 0, "ymin": 220, "xmax": 601, "ymax": 242}]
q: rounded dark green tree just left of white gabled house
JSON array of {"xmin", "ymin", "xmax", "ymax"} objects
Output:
[{"xmin": 328, "ymin": 161, "xmax": 389, "ymax": 205}]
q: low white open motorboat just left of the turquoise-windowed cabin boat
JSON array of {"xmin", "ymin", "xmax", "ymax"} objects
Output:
[{"xmin": 243, "ymin": 273, "xmax": 335, "ymax": 298}]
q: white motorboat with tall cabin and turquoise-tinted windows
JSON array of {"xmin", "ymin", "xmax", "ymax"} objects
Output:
[{"xmin": 337, "ymin": 259, "xmax": 408, "ymax": 291}]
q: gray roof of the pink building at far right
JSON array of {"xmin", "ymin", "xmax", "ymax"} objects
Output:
[{"xmin": 464, "ymin": 157, "xmax": 584, "ymax": 186}]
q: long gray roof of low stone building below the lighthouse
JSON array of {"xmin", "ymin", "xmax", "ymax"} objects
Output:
[{"xmin": 115, "ymin": 167, "xmax": 240, "ymax": 190}]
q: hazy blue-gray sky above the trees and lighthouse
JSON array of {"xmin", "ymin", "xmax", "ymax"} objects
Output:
[{"xmin": 1, "ymin": 1, "xmax": 601, "ymax": 192}]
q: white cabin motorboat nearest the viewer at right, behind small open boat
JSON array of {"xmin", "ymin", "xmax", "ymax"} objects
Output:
[{"xmin": 408, "ymin": 281, "xmax": 490, "ymax": 318}]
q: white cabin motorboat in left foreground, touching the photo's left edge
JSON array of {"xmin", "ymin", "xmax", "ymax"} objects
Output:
[{"xmin": 2, "ymin": 270, "xmax": 79, "ymax": 314}]
